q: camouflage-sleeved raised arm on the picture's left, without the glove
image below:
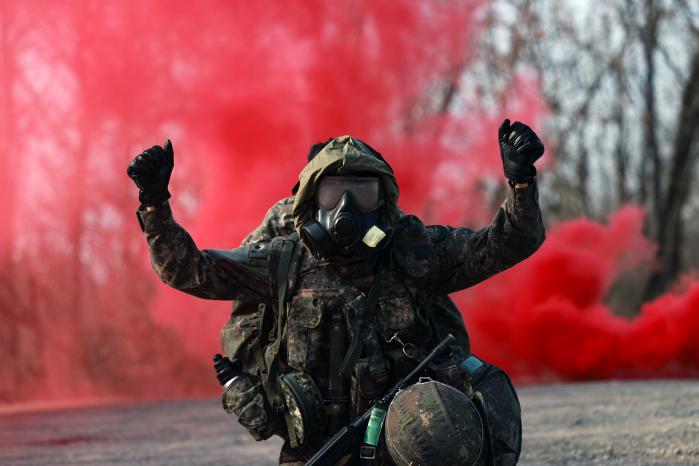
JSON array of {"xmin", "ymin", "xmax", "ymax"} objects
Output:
[{"xmin": 138, "ymin": 203, "xmax": 270, "ymax": 301}]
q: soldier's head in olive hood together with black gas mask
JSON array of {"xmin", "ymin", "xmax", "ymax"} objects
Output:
[{"xmin": 292, "ymin": 136, "xmax": 398, "ymax": 259}]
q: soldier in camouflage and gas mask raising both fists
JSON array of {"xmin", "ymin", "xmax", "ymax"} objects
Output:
[{"xmin": 128, "ymin": 120, "xmax": 544, "ymax": 464}]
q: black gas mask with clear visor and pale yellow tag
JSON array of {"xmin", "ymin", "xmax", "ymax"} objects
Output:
[{"xmin": 302, "ymin": 176, "xmax": 391, "ymax": 258}]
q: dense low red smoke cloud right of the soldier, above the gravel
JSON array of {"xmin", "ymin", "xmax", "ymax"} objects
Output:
[{"xmin": 458, "ymin": 207, "xmax": 699, "ymax": 380}]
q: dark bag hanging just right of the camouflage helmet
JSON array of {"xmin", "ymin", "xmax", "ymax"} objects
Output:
[{"xmin": 468, "ymin": 356, "xmax": 522, "ymax": 466}]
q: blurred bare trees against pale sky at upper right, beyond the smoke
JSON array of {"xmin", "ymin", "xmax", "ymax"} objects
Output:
[{"xmin": 470, "ymin": 0, "xmax": 699, "ymax": 302}]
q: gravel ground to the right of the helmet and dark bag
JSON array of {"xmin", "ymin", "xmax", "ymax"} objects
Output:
[{"xmin": 519, "ymin": 381, "xmax": 699, "ymax": 466}]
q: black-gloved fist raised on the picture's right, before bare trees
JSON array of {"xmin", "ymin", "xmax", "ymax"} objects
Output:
[{"xmin": 498, "ymin": 119, "xmax": 544, "ymax": 184}]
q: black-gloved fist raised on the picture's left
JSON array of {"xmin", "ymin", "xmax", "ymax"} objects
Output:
[{"xmin": 126, "ymin": 139, "xmax": 175, "ymax": 209}]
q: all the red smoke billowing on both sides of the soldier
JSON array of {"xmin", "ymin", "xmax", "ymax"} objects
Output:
[{"xmin": 0, "ymin": 0, "xmax": 699, "ymax": 408}]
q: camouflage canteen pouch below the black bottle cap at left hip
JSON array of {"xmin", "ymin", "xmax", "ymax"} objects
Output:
[{"xmin": 221, "ymin": 374, "xmax": 282, "ymax": 441}]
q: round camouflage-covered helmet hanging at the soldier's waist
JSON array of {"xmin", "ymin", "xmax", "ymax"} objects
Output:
[{"xmin": 386, "ymin": 379, "xmax": 484, "ymax": 466}]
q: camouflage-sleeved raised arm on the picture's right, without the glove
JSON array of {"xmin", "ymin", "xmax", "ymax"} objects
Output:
[{"xmin": 430, "ymin": 181, "xmax": 545, "ymax": 293}]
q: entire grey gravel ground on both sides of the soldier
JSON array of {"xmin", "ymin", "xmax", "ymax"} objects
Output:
[{"xmin": 0, "ymin": 381, "xmax": 699, "ymax": 466}]
